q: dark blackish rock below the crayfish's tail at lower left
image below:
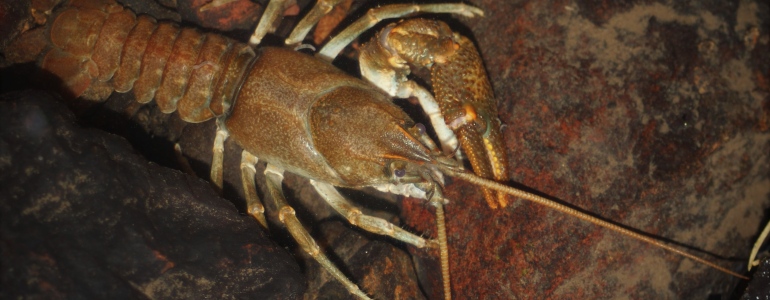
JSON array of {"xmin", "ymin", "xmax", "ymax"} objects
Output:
[{"xmin": 0, "ymin": 92, "xmax": 305, "ymax": 299}]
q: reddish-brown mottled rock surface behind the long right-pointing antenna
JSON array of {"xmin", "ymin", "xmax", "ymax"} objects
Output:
[{"xmin": 403, "ymin": 0, "xmax": 770, "ymax": 299}]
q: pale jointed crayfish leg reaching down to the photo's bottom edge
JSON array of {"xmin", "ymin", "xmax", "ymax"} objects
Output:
[{"xmin": 265, "ymin": 164, "xmax": 370, "ymax": 299}]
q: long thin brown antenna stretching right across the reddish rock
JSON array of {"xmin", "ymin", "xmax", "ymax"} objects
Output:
[{"xmin": 438, "ymin": 165, "xmax": 749, "ymax": 280}]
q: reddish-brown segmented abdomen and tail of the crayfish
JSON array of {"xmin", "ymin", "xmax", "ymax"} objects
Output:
[{"xmin": 41, "ymin": 1, "xmax": 255, "ymax": 123}]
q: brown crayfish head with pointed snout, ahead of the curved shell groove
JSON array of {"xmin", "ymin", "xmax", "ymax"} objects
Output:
[{"xmin": 308, "ymin": 86, "xmax": 450, "ymax": 194}]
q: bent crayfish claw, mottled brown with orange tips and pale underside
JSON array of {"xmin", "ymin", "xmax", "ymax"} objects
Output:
[{"xmin": 360, "ymin": 19, "xmax": 508, "ymax": 208}]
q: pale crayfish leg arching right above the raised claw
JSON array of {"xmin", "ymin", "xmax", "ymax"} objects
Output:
[{"xmin": 318, "ymin": 3, "xmax": 484, "ymax": 60}]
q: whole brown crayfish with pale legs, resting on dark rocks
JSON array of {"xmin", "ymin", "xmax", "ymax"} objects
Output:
[{"xmin": 0, "ymin": 0, "xmax": 760, "ymax": 299}]
